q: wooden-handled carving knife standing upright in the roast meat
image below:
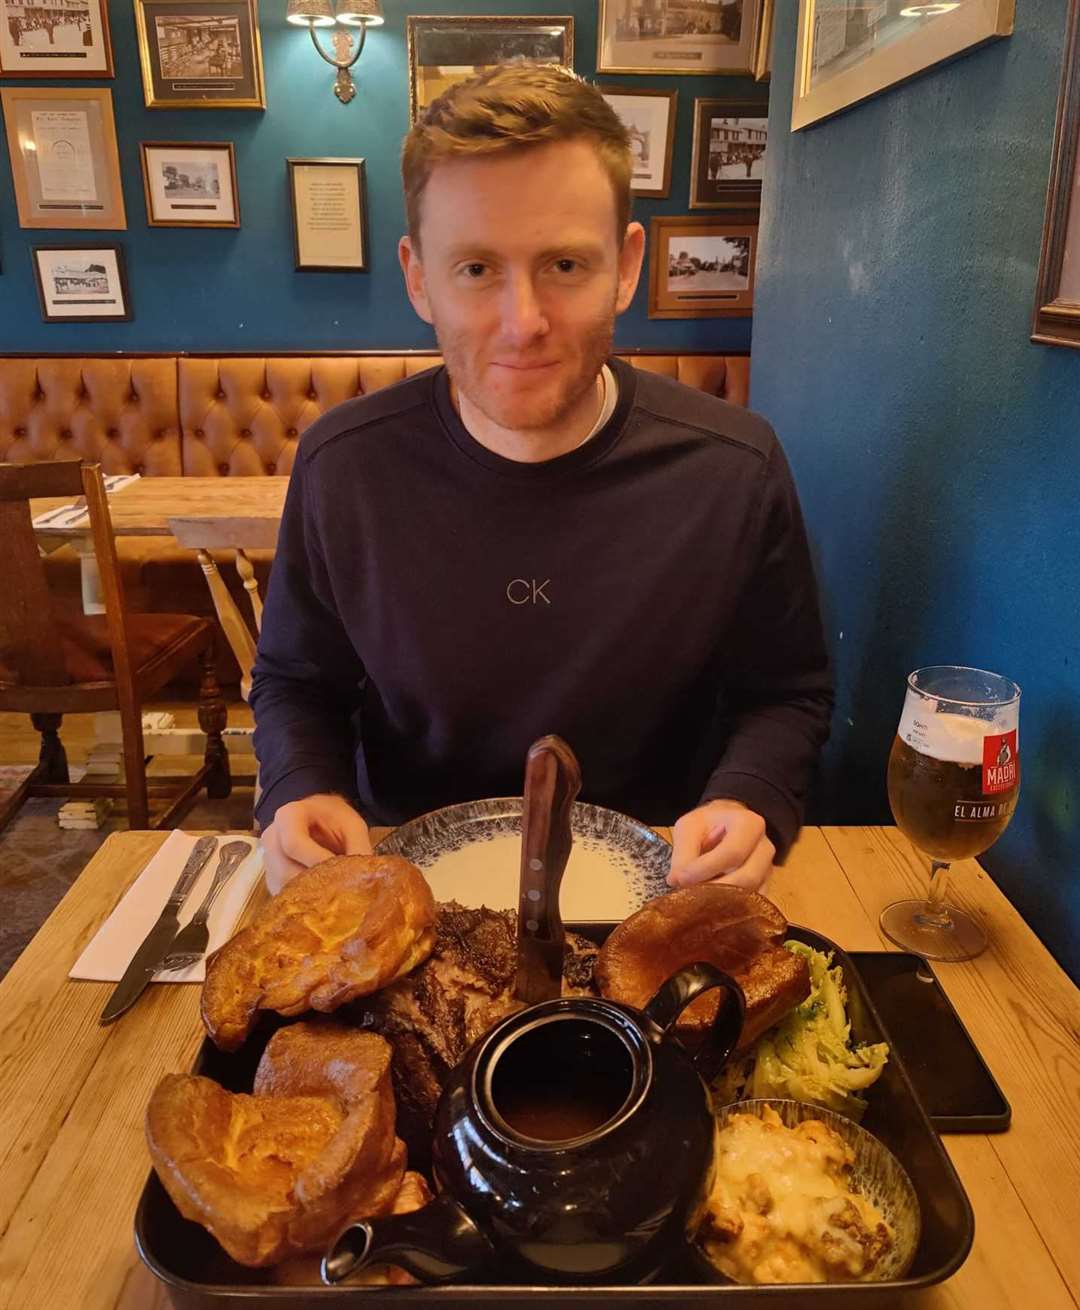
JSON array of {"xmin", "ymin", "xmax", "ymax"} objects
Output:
[{"xmin": 514, "ymin": 736, "xmax": 581, "ymax": 1005}]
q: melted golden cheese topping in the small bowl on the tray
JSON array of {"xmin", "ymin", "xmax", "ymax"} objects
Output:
[{"xmin": 700, "ymin": 1107, "xmax": 894, "ymax": 1282}]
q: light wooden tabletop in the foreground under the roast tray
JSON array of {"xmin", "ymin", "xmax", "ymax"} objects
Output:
[{"xmin": 0, "ymin": 828, "xmax": 1080, "ymax": 1310}]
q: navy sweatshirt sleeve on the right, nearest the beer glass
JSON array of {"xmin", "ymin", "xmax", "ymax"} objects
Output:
[{"xmin": 701, "ymin": 443, "xmax": 832, "ymax": 863}]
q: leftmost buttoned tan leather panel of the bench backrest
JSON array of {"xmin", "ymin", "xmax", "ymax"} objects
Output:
[{"xmin": 0, "ymin": 355, "xmax": 182, "ymax": 477}]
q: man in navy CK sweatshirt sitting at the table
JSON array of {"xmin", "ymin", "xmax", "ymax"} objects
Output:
[{"xmin": 252, "ymin": 67, "xmax": 831, "ymax": 889}]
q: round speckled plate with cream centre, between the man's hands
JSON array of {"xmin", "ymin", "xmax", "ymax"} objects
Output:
[{"xmin": 379, "ymin": 796, "xmax": 671, "ymax": 922}]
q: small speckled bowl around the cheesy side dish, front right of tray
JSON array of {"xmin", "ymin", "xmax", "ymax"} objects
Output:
[{"xmin": 699, "ymin": 1099, "xmax": 923, "ymax": 1282}]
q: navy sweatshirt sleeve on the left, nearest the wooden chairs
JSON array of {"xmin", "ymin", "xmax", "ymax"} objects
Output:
[{"xmin": 249, "ymin": 447, "xmax": 364, "ymax": 828}]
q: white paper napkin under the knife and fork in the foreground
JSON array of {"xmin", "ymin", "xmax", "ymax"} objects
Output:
[{"xmin": 68, "ymin": 828, "xmax": 262, "ymax": 983}]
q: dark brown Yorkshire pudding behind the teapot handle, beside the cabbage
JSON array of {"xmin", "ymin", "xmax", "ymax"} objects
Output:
[{"xmin": 596, "ymin": 883, "xmax": 810, "ymax": 1049}]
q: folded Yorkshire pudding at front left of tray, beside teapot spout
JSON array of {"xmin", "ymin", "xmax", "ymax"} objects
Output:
[{"xmin": 145, "ymin": 1023, "xmax": 405, "ymax": 1265}]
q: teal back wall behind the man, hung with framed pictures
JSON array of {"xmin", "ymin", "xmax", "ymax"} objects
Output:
[{"xmin": 0, "ymin": 0, "xmax": 768, "ymax": 352}]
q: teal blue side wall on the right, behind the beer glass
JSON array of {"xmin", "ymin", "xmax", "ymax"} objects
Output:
[{"xmin": 754, "ymin": 0, "xmax": 1080, "ymax": 979}]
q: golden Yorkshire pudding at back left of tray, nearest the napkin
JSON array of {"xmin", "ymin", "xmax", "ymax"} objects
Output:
[{"xmin": 202, "ymin": 855, "xmax": 435, "ymax": 1051}]
